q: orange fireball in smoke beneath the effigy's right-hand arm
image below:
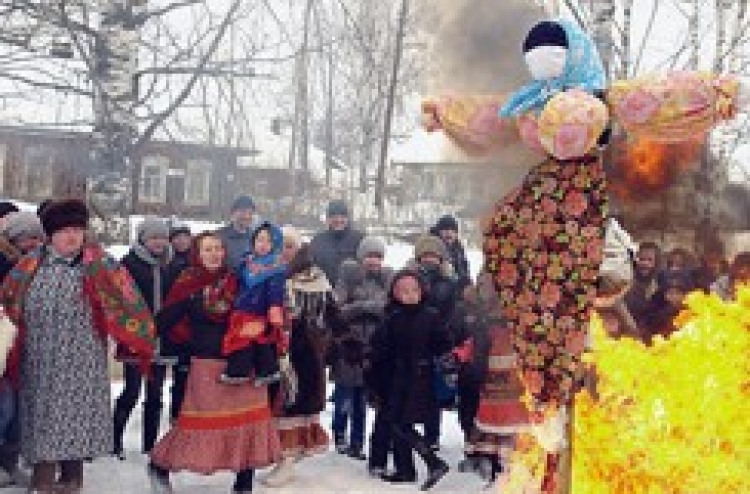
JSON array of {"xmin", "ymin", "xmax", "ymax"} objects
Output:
[{"xmin": 610, "ymin": 138, "xmax": 703, "ymax": 201}]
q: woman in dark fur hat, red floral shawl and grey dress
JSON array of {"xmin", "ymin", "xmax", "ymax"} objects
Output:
[{"xmin": 0, "ymin": 200, "xmax": 155, "ymax": 493}]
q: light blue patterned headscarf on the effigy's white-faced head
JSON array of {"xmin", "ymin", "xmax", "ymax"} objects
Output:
[{"xmin": 499, "ymin": 19, "xmax": 607, "ymax": 118}]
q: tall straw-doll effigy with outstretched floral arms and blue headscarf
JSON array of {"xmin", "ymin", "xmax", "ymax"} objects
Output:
[{"xmin": 423, "ymin": 15, "xmax": 750, "ymax": 493}]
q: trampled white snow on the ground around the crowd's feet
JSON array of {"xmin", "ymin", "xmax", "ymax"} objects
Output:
[{"xmin": 0, "ymin": 384, "xmax": 491, "ymax": 494}]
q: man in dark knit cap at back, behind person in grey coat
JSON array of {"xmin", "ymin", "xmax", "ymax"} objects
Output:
[{"xmin": 310, "ymin": 200, "xmax": 364, "ymax": 282}]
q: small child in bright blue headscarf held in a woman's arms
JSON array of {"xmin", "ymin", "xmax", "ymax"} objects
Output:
[{"xmin": 221, "ymin": 222, "xmax": 286, "ymax": 386}]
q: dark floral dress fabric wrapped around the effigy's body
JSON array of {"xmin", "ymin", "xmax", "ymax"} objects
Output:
[{"xmin": 485, "ymin": 156, "xmax": 608, "ymax": 403}]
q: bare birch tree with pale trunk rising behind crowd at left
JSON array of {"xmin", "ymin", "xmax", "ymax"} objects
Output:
[{"xmin": 0, "ymin": 0, "xmax": 262, "ymax": 239}]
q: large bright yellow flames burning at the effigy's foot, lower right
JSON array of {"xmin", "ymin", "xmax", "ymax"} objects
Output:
[{"xmin": 502, "ymin": 287, "xmax": 750, "ymax": 494}]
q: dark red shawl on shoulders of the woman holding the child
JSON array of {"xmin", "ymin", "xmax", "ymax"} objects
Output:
[{"xmin": 164, "ymin": 264, "xmax": 237, "ymax": 344}]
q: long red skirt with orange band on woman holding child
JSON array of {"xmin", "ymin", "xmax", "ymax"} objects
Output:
[{"xmin": 151, "ymin": 359, "xmax": 281, "ymax": 475}]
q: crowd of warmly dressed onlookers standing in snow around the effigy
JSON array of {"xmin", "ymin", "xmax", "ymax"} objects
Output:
[{"xmin": 0, "ymin": 196, "xmax": 750, "ymax": 493}]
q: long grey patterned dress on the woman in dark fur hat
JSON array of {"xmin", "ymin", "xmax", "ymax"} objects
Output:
[{"xmin": 19, "ymin": 254, "xmax": 114, "ymax": 464}]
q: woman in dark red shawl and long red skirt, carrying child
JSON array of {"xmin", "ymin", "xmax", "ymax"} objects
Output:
[{"xmin": 149, "ymin": 233, "xmax": 281, "ymax": 494}]
